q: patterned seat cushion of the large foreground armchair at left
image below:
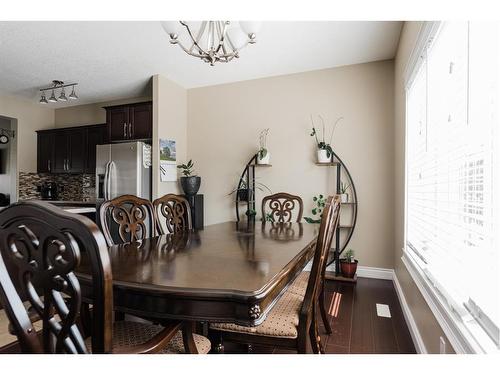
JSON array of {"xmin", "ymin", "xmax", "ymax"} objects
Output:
[{"xmin": 85, "ymin": 320, "xmax": 211, "ymax": 354}]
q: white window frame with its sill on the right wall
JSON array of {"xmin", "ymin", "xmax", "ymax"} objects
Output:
[{"xmin": 401, "ymin": 22, "xmax": 498, "ymax": 353}]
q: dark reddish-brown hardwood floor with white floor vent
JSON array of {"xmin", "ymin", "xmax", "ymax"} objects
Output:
[{"xmin": 224, "ymin": 278, "xmax": 415, "ymax": 354}]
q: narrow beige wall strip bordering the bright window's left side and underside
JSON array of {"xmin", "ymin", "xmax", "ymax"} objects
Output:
[{"xmin": 394, "ymin": 22, "xmax": 453, "ymax": 353}]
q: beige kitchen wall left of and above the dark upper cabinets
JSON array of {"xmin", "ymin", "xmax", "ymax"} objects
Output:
[{"xmin": 0, "ymin": 96, "xmax": 54, "ymax": 172}]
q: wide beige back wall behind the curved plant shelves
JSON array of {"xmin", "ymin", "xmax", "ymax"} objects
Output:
[{"xmin": 187, "ymin": 61, "xmax": 394, "ymax": 268}]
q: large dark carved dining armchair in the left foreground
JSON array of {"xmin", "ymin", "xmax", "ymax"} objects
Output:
[{"xmin": 0, "ymin": 202, "xmax": 210, "ymax": 354}]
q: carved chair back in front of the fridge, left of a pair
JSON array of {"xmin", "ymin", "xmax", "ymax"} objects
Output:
[{"xmin": 99, "ymin": 195, "xmax": 156, "ymax": 246}]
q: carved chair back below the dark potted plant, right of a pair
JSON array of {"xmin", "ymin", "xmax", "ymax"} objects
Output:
[{"xmin": 153, "ymin": 194, "xmax": 193, "ymax": 234}]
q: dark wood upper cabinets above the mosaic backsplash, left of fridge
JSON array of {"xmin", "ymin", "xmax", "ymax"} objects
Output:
[{"xmin": 37, "ymin": 124, "xmax": 108, "ymax": 173}]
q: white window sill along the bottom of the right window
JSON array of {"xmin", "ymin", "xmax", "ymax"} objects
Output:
[{"xmin": 401, "ymin": 249, "xmax": 498, "ymax": 354}]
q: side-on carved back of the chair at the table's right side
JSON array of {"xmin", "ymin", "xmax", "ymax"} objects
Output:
[{"xmin": 299, "ymin": 195, "xmax": 340, "ymax": 332}]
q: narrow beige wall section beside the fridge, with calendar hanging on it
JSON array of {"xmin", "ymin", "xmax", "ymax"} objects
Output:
[{"xmin": 153, "ymin": 75, "xmax": 187, "ymax": 199}]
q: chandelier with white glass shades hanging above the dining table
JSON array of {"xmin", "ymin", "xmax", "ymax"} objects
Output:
[{"xmin": 161, "ymin": 21, "xmax": 260, "ymax": 66}]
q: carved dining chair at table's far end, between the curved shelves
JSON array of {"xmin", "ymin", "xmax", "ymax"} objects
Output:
[{"xmin": 262, "ymin": 192, "xmax": 304, "ymax": 223}]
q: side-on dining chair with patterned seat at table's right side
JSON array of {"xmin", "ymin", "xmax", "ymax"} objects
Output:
[{"xmin": 210, "ymin": 195, "xmax": 340, "ymax": 353}]
